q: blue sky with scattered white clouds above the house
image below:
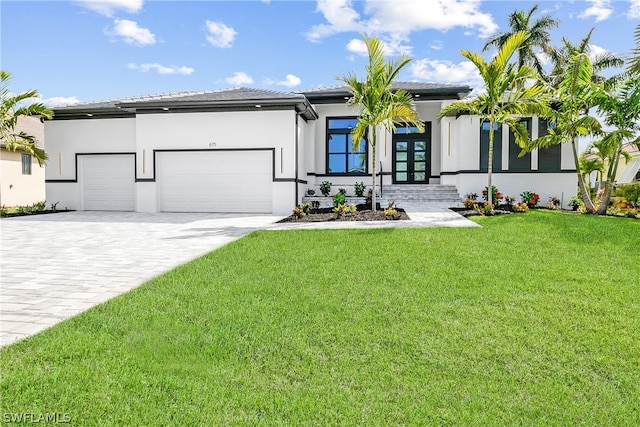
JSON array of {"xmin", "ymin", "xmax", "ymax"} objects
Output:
[{"xmin": 0, "ymin": 0, "xmax": 640, "ymax": 106}]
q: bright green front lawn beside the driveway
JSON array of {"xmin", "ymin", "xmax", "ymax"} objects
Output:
[{"xmin": 0, "ymin": 211, "xmax": 640, "ymax": 426}]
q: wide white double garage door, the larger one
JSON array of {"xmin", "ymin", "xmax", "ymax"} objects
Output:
[{"xmin": 156, "ymin": 151, "xmax": 273, "ymax": 213}]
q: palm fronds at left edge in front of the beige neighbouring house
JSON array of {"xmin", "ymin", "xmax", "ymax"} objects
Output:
[{"xmin": 0, "ymin": 70, "xmax": 53, "ymax": 166}]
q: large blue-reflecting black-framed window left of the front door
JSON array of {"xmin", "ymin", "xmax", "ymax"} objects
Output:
[{"xmin": 327, "ymin": 117, "xmax": 367, "ymax": 175}]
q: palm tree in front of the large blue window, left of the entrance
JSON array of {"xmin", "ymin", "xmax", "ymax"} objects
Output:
[{"xmin": 337, "ymin": 35, "xmax": 424, "ymax": 211}]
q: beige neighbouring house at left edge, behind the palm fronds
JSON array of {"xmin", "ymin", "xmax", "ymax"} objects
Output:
[{"xmin": 0, "ymin": 116, "xmax": 45, "ymax": 207}]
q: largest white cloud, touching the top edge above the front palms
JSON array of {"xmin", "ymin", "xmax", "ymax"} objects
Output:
[{"xmin": 306, "ymin": 0, "xmax": 498, "ymax": 41}]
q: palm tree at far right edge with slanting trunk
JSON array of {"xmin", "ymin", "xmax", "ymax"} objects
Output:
[{"xmin": 598, "ymin": 75, "xmax": 640, "ymax": 214}]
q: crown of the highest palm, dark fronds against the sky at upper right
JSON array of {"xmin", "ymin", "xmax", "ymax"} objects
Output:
[{"xmin": 482, "ymin": 4, "xmax": 560, "ymax": 75}]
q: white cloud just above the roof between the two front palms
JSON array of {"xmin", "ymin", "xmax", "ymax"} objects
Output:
[{"xmin": 409, "ymin": 58, "xmax": 482, "ymax": 86}]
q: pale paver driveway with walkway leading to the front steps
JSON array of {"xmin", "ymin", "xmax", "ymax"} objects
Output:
[{"xmin": 0, "ymin": 209, "xmax": 477, "ymax": 346}]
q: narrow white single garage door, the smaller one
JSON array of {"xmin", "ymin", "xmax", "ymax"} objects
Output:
[{"xmin": 80, "ymin": 154, "xmax": 136, "ymax": 211}]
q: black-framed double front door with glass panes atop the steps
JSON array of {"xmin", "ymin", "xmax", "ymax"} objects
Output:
[{"xmin": 392, "ymin": 123, "xmax": 431, "ymax": 184}]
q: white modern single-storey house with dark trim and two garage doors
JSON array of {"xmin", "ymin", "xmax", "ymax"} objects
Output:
[{"xmin": 45, "ymin": 83, "xmax": 576, "ymax": 214}]
